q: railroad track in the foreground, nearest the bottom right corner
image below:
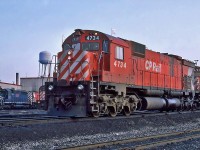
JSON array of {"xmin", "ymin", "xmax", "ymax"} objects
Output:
[{"xmin": 61, "ymin": 129, "xmax": 200, "ymax": 150}]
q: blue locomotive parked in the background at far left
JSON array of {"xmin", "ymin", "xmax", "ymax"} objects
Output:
[{"xmin": 0, "ymin": 88, "xmax": 35, "ymax": 109}]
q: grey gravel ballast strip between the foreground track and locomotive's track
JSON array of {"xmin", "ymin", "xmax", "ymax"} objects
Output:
[{"xmin": 0, "ymin": 112, "xmax": 200, "ymax": 150}]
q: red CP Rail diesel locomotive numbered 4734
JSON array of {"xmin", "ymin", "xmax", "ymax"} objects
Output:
[{"xmin": 44, "ymin": 29, "xmax": 200, "ymax": 117}]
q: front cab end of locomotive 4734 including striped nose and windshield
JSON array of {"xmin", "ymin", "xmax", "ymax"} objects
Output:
[{"xmin": 58, "ymin": 29, "xmax": 110, "ymax": 81}]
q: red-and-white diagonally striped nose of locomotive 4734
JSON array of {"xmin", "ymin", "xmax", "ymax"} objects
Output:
[{"xmin": 58, "ymin": 43, "xmax": 90, "ymax": 81}]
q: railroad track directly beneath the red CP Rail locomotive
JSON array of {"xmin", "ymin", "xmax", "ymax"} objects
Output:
[{"xmin": 0, "ymin": 110, "xmax": 200, "ymax": 127}]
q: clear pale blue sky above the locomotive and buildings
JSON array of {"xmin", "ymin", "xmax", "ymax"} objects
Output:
[{"xmin": 0, "ymin": 0, "xmax": 200, "ymax": 83}]
